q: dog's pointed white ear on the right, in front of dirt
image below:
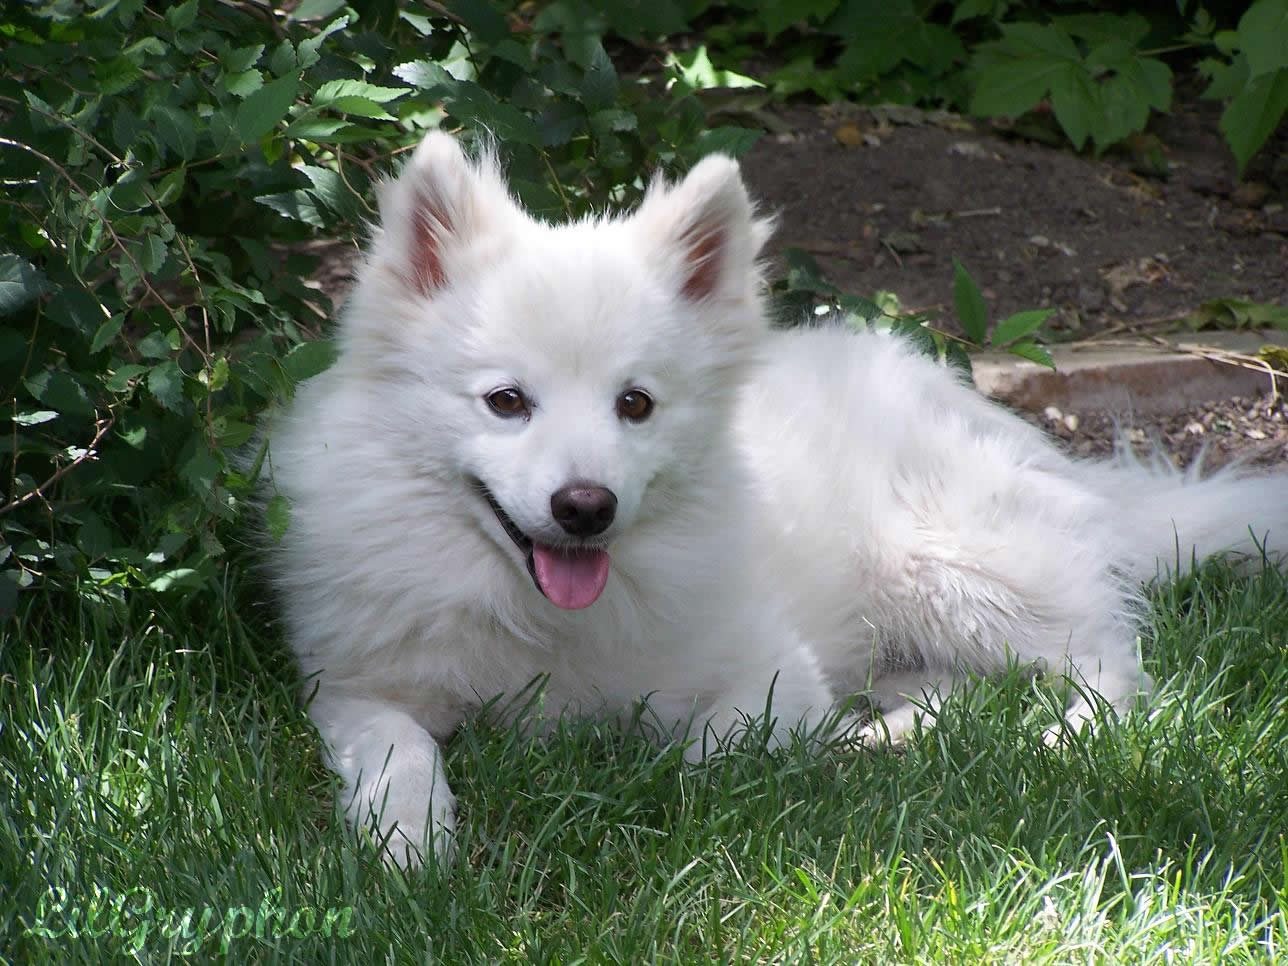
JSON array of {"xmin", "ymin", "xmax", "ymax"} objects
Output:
[{"xmin": 636, "ymin": 155, "xmax": 772, "ymax": 301}]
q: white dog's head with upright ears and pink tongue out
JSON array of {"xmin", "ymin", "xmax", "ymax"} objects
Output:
[{"xmin": 341, "ymin": 133, "xmax": 769, "ymax": 609}]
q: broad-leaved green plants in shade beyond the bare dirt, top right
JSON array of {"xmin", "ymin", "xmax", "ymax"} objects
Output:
[{"xmin": 716, "ymin": 0, "xmax": 1288, "ymax": 171}]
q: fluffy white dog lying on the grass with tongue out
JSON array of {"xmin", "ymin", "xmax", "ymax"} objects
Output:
[{"xmin": 270, "ymin": 134, "xmax": 1288, "ymax": 862}]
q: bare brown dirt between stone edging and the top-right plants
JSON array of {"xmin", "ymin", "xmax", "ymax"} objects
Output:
[{"xmin": 743, "ymin": 91, "xmax": 1288, "ymax": 337}]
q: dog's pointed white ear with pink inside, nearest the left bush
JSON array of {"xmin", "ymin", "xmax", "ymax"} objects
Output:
[{"xmin": 374, "ymin": 131, "xmax": 519, "ymax": 295}]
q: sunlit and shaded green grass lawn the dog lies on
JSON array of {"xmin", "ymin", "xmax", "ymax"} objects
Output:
[{"xmin": 0, "ymin": 568, "xmax": 1288, "ymax": 963}]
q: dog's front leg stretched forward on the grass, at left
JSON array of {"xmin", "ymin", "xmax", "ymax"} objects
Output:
[{"xmin": 309, "ymin": 689, "xmax": 456, "ymax": 867}]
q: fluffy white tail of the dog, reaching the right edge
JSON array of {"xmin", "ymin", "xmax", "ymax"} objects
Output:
[{"xmin": 1086, "ymin": 453, "xmax": 1288, "ymax": 581}]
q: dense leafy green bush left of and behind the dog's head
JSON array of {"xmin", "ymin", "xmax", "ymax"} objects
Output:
[{"xmin": 0, "ymin": 0, "xmax": 755, "ymax": 612}]
